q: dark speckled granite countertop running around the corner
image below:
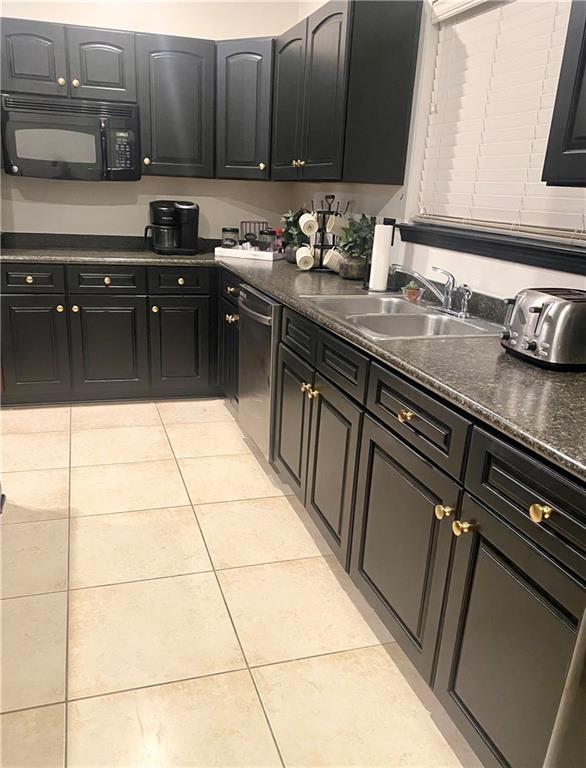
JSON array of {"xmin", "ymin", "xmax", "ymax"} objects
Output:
[{"xmin": 3, "ymin": 250, "xmax": 586, "ymax": 481}]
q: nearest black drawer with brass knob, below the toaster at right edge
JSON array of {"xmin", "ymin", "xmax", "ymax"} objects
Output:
[{"xmin": 465, "ymin": 427, "xmax": 586, "ymax": 577}]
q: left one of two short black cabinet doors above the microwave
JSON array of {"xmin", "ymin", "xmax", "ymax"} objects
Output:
[{"xmin": 2, "ymin": 19, "xmax": 67, "ymax": 96}]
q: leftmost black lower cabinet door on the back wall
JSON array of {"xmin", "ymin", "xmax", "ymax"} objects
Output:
[{"xmin": 2, "ymin": 295, "xmax": 71, "ymax": 403}]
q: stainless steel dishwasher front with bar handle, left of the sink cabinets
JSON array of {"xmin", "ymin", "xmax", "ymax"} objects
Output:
[{"xmin": 238, "ymin": 284, "xmax": 281, "ymax": 459}]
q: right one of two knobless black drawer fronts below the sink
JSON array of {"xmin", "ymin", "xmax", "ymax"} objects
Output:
[{"xmin": 316, "ymin": 331, "xmax": 368, "ymax": 403}]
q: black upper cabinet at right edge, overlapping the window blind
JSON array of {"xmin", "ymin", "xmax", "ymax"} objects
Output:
[{"xmin": 542, "ymin": 0, "xmax": 586, "ymax": 187}]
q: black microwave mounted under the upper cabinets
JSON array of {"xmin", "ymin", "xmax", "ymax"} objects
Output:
[{"xmin": 2, "ymin": 94, "xmax": 141, "ymax": 181}]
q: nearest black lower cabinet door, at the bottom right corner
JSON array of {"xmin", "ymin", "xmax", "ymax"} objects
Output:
[{"xmin": 434, "ymin": 496, "xmax": 586, "ymax": 768}]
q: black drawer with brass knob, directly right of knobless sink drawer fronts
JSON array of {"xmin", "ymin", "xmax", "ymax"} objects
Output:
[{"xmin": 366, "ymin": 365, "xmax": 471, "ymax": 478}]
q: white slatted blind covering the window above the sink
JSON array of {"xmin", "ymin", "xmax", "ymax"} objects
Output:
[{"xmin": 415, "ymin": 0, "xmax": 586, "ymax": 245}]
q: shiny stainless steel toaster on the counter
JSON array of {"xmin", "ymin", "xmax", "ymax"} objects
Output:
[{"xmin": 501, "ymin": 288, "xmax": 586, "ymax": 370}]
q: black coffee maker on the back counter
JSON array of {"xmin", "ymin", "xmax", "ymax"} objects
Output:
[{"xmin": 144, "ymin": 200, "xmax": 199, "ymax": 255}]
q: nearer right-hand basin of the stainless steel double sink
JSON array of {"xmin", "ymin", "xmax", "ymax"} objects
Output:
[{"xmin": 347, "ymin": 312, "xmax": 489, "ymax": 339}]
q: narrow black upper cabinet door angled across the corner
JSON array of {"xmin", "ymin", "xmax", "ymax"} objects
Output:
[{"xmin": 216, "ymin": 38, "xmax": 273, "ymax": 179}]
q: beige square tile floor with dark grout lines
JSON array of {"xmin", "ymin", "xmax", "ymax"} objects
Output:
[{"xmin": 0, "ymin": 400, "xmax": 477, "ymax": 768}]
